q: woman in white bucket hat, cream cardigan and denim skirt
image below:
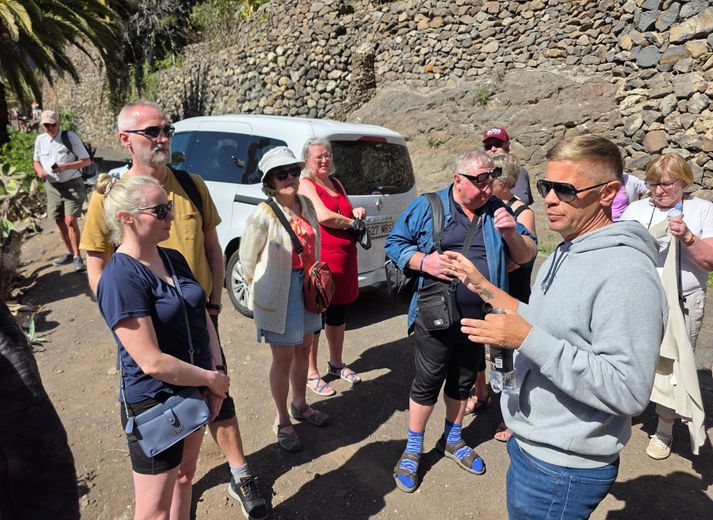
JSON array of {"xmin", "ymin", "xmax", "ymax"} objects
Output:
[{"xmin": 240, "ymin": 146, "xmax": 329, "ymax": 451}]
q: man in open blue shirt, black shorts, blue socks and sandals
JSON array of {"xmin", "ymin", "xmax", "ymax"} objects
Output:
[{"xmin": 386, "ymin": 152, "xmax": 537, "ymax": 493}]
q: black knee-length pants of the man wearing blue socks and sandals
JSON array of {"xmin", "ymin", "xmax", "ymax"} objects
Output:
[{"xmin": 410, "ymin": 315, "xmax": 485, "ymax": 406}]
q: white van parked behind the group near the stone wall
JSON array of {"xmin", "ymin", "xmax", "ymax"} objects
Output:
[{"xmin": 172, "ymin": 115, "xmax": 416, "ymax": 316}]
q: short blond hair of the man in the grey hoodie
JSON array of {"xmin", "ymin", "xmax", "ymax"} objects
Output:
[{"xmin": 545, "ymin": 134, "xmax": 624, "ymax": 182}]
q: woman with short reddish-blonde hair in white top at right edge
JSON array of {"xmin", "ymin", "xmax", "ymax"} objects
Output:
[{"xmin": 621, "ymin": 153, "xmax": 713, "ymax": 459}]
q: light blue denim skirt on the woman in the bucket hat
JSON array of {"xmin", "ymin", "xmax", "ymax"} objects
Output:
[{"xmin": 257, "ymin": 269, "xmax": 322, "ymax": 345}]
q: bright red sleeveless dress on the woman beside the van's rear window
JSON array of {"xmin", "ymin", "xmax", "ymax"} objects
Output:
[{"xmin": 307, "ymin": 179, "xmax": 359, "ymax": 305}]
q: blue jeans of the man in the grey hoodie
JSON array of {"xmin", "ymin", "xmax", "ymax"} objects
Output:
[{"xmin": 507, "ymin": 437, "xmax": 619, "ymax": 520}]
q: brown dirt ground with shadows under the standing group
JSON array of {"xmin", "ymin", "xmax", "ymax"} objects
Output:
[{"xmin": 15, "ymin": 213, "xmax": 713, "ymax": 520}]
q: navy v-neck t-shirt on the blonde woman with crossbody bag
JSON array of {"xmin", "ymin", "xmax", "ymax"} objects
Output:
[{"xmin": 97, "ymin": 248, "xmax": 211, "ymax": 403}]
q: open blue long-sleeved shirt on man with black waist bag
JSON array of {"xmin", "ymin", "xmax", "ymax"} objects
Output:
[{"xmin": 385, "ymin": 185, "xmax": 535, "ymax": 330}]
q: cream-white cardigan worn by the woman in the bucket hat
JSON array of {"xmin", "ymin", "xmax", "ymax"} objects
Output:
[{"xmin": 240, "ymin": 195, "xmax": 321, "ymax": 334}]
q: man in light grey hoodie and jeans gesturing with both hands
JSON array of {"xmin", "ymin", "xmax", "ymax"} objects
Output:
[{"xmin": 446, "ymin": 135, "xmax": 667, "ymax": 520}]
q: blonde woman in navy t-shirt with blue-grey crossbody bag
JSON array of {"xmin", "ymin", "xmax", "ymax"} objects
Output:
[{"xmin": 97, "ymin": 176, "xmax": 230, "ymax": 519}]
